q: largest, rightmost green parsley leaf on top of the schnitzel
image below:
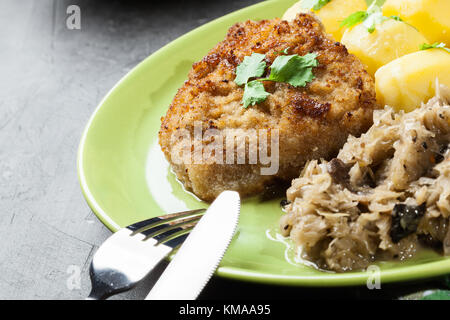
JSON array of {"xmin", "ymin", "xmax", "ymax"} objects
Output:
[{"xmin": 263, "ymin": 53, "xmax": 318, "ymax": 87}]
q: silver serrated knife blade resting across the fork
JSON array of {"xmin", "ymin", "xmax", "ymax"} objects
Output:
[{"xmin": 145, "ymin": 191, "xmax": 240, "ymax": 300}]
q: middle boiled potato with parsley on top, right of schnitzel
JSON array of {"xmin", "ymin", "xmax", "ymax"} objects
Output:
[{"xmin": 341, "ymin": 18, "xmax": 428, "ymax": 75}]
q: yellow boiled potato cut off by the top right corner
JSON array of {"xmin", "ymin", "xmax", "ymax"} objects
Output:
[{"xmin": 383, "ymin": 0, "xmax": 450, "ymax": 45}]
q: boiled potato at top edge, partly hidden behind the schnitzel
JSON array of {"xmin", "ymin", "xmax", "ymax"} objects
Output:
[{"xmin": 283, "ymin": 0, "xmax": 367, "ymax": 41}]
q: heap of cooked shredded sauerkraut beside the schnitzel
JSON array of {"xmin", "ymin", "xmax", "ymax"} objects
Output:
[{"xmin": 280, "ymin": 86, "xmax": 450, "ymax": 272}]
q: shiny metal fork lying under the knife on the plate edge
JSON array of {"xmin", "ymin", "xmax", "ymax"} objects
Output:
[{"xmin": 87, "ymin": 209, "xmax": 206, "ymax": 300}]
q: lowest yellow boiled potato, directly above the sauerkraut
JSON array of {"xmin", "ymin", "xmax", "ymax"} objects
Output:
[{"xmin": 375, "ymin": 49, "xmax": 450, "ymax": 112}]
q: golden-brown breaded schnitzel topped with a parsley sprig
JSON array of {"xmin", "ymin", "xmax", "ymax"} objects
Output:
[{"xmin": 159, "ymin": 14, "xmax": 377, "ymax": 200}]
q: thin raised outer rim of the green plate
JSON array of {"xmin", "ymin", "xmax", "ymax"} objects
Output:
[{"xmin": 77, "ymin": 1, "xmax": 450, "ymax": 287}]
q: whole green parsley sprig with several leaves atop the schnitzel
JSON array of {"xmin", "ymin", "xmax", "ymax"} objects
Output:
[{"xmin": 234, "ymin": 52, "xmax": 318, "ymax": 108}]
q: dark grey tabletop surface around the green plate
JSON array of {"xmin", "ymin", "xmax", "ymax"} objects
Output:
[{"xmin": 0, "ymin": 0, "xmax": 442, "ymax": 299}]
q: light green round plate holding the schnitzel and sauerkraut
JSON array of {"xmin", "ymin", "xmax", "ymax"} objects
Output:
[{"xmin": 78, "ymin": 0, "xmax": 450, "ymax": 286}]
